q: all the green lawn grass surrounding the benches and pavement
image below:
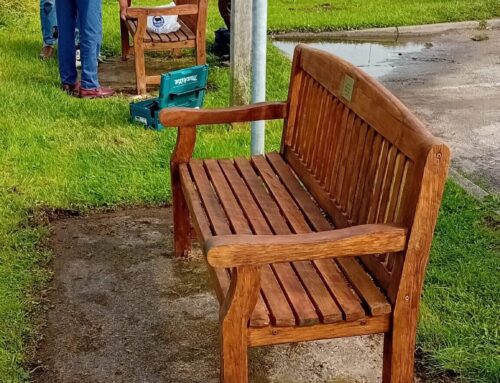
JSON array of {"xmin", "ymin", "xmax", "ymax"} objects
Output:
[{"xmin": 0, "ymin": 0, "xmax": 500, "ymax": 382}]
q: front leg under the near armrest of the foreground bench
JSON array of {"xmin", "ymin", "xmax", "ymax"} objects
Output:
[{"xmin": 220, "ymin": 266, "xmax": 260, "ymax": 383}]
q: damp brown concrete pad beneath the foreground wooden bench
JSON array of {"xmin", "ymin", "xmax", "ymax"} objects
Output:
[{"xmin": 31, "ymin": 208, "xmax": 398, "ymax": 383}]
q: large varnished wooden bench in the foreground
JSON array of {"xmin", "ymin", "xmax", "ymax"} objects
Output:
[{"xmin": 160, "ymin": 46, "xmax": 450, "ymax": 383}]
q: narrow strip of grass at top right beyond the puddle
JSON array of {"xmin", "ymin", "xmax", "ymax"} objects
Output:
[{"xmin": 269, "ymin": 0, "xmax": 500, "ymax": 32}]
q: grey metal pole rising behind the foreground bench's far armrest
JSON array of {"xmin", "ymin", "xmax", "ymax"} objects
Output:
[{"xmin": 251, "ymin": 0, "xmax": 267, "ymax": 155}]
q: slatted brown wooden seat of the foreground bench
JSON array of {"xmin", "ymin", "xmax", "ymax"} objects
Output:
[{"xmin": 180, "ymin": 153, "xmax": 391, "ymax": 328}]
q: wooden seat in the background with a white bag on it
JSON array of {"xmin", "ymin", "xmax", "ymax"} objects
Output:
[{"xmin": 120, "ymin": 0, "xmax": 207, "ymax": 94}]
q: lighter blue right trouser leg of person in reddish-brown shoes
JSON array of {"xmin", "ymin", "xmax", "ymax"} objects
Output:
[{"xmin": 76, "ymin": 0, "xmax": 102, "ymax": 89}]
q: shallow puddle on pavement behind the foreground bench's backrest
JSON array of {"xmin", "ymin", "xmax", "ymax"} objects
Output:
[{"xmin": 273, "ymin": 40, "xmax": 430, "ymax": 77}]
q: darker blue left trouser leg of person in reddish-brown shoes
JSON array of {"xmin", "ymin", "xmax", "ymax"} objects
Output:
[{"xmin": 56, "ymin": 0, "xmax": 78, "ymax": 85}]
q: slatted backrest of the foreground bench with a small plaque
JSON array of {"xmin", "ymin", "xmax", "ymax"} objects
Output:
[{"xmin": 281, "ymin": 45, "xmax": 449, "ymax": 301}]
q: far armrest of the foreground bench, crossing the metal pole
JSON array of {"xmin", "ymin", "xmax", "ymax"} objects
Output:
[{"xmin": 160, "ymin": 102, "xmax": 288, "ymax": 127}]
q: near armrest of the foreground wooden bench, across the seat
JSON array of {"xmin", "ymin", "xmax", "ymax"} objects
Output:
[{"xmin": 205, "ymin": 224, "xmax": 407, "ymax": 268}]
